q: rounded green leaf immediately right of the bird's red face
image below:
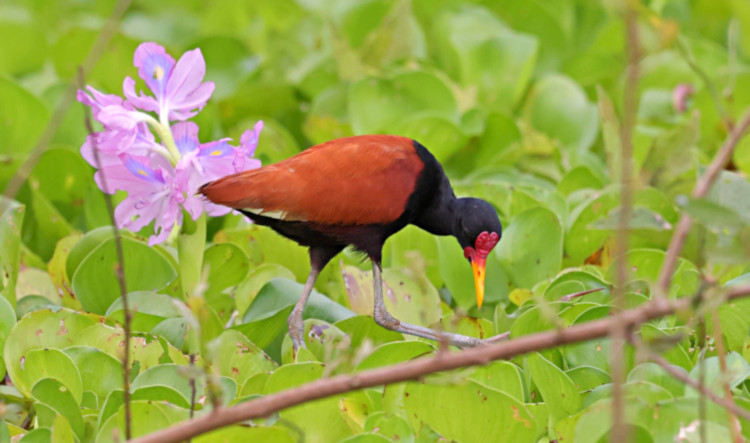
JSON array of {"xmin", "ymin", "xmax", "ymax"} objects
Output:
[{"xmin": 497, "ymin": 208, "xmax": 563, "ymax": 289}]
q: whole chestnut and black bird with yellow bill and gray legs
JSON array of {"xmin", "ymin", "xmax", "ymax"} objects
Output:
[{"xmin": 199, "ymin": 135, "xmax": 502, "ymax": 353}]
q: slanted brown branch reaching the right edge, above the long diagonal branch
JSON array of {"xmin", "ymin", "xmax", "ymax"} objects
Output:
[{"xmin": 658, "ymin": 108, "xmax": 750, "ymax": 297}]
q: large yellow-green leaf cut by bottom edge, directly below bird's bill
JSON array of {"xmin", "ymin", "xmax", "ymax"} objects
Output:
[{"xmin": 404, "ymin": 381, "xmax": 539, "ymax": 441}]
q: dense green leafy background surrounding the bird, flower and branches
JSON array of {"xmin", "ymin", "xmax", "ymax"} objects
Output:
[{"xmin": 0, "ymin": 0, "xmax": 750, "ymax": 442}]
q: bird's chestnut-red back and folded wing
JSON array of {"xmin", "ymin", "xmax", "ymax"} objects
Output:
[{"xmin": 201, "ymin": 135, "xmax": 425, "ymax": 226}]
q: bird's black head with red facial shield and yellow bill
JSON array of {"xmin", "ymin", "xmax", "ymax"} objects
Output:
[{"xmin": 456, "ymin": 198, "xmax": 503, "ymax": 307}]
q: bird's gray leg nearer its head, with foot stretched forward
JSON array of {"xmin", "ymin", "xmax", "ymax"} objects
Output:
[{"xmin": 372, "ymin": 260, "xmax": 482, "ymax": 348}]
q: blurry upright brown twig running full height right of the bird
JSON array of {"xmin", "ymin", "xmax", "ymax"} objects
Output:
[{"xmin": 609, "ymin": 2, "xmax": 640, "ymax": 442}]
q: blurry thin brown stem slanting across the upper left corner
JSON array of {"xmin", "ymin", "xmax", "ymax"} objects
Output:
[{"xmin": 3, "ymin": 0, "xmax": 132, "ymax": 205}]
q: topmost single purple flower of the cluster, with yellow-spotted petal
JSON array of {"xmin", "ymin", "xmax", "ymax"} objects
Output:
[{"xmin": 123, "ymin": 43, "xmax": 214, "ymax": 121}]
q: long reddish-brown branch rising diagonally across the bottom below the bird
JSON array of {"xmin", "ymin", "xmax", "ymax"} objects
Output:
[{"xmin": 133, "ymin": 285, "xmax": 750, "ymax": 443}]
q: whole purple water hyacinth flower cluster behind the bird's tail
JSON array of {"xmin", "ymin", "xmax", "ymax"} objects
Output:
[{"xmin": 76, "ymin": 43, "xmax": 263, "ymax": 245}]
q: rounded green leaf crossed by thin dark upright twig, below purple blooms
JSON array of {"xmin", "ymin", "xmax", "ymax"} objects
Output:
[{"xmin": 69, "ymin": 237, "xmax": 177, "ymax": 314}]
